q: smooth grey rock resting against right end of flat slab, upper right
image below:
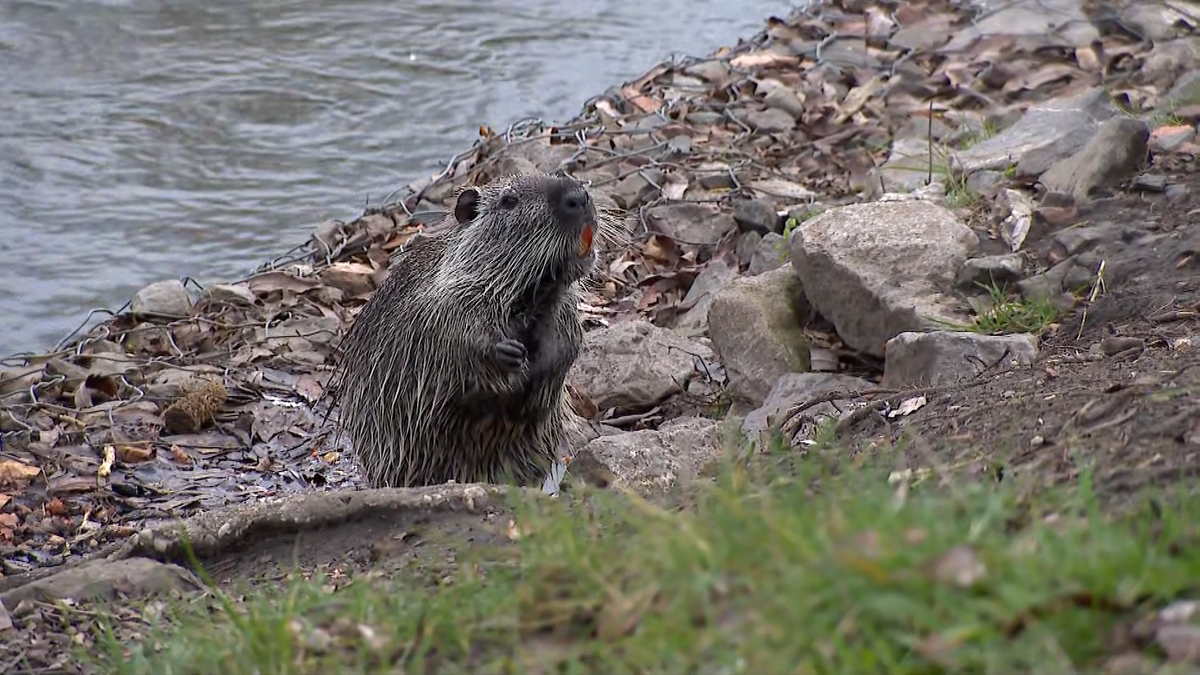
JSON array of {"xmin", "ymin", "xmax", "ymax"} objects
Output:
[{"xmin": 1042, "ymin": 117, "xmax": 1150, "ymax": 202}]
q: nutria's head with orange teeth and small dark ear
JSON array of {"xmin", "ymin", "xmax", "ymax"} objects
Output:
[{"xmin": 442, "ymin": 173, "xmax": 601, "ymax": 295}]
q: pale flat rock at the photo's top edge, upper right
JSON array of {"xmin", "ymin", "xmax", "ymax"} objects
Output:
[{"xmin": 944, "ymin": 0, "xmax": 1100, "ymax": 53}]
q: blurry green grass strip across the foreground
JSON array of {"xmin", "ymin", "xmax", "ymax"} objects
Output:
[{"xmin": 87, "ymin": 427, "xmax": 1200, "ymax": 675}]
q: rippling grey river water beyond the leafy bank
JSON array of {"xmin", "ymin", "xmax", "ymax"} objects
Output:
[{"xmin": 0, "ymin": 0, "xmax": 792, "ymax": 356}]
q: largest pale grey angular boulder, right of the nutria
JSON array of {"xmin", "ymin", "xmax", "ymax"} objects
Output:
[{"xmin": 790, "ymin": 201, "xmax": 979, "ymax": 357}]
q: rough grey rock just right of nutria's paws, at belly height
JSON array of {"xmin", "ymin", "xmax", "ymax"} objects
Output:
[{"xmin": 568, "ymin": 321, "xmax": 713, "ymax": 414}]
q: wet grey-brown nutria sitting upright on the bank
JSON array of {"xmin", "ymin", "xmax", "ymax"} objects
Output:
[{"xmin": 336, "ymin": 173, "xmax": 601, "ymax": 486}]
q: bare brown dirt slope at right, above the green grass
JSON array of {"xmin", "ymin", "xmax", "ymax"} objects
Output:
[{"xmin": 842, "ymin": 169, "xmax": 1200, "ymax": 501}]
